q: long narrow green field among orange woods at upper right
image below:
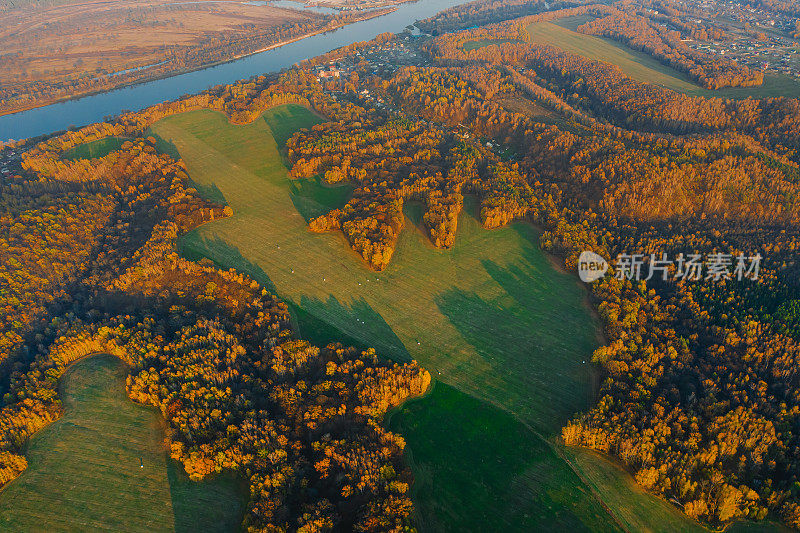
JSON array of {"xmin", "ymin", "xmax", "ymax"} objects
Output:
[{"xmin": 527, "ymin": 16, "xmax": 800, "ymax": 98}]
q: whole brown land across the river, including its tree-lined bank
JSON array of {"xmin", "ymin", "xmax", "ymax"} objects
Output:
[{"xmin": 0, "ymin": 0, "xmax": 336, "ymax": 114}]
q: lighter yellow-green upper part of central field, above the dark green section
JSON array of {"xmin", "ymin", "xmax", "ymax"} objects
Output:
[{"xmin": 153, "ymin": 106, "xmax": 597, "ymax": 434}]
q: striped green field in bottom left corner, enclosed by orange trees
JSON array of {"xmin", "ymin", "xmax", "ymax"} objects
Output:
[{"xmin": 0, "ymin": 355, "xmax": 244, "ymax": 533}]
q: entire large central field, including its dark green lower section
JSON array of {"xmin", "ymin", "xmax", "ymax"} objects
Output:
[{"xmin": 142, "ymin": 105, "xmax": 712, "ymax": 531}]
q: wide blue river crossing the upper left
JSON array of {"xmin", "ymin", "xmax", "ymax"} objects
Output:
[{"xmin": 0, "ymin": 0, "xmax": 469, "ymax": 140}]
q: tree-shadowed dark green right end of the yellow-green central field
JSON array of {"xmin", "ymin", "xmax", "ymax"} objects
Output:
[{"xmin": 434, "ymin": 251, "xmax": 595, "ymax": 435}]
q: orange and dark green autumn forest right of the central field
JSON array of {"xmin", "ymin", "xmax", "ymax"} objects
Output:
[{"xmin": 268, "ymin": 13, "xmax": 800, "ymax": 527}]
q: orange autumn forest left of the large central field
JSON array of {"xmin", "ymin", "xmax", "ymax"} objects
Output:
[{"xmin": 0, "ymin": 77, "xmax": 431, "ymax": 531}]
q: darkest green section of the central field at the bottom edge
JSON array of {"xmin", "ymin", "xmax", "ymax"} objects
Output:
[{"xmin": 389, "ymin": 382, "xmax": 615, "ymax": 532}]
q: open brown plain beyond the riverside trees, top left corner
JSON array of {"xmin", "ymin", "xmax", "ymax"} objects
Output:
[{"xmin": 0, "ymin": 0, "xmax": 313, "ymax": 86}]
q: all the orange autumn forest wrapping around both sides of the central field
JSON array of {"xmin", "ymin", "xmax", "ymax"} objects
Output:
[{"xmin": 0, "ymin": 1, "xmax": 800, "ymax": 531}]
